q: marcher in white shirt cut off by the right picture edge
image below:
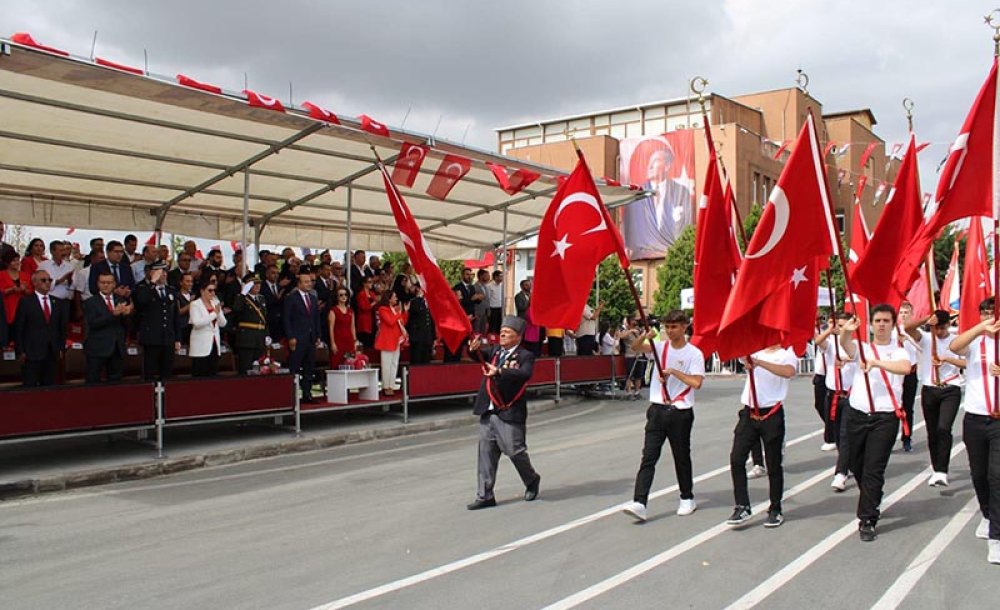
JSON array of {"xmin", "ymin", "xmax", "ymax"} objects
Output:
[{"xmin": 949, "ymin": 297, "xmax": 1000, "ymax": 564}]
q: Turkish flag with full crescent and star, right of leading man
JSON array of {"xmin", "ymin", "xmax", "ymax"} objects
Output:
[{"xmin": 531, "ymin": 153, "xmax": 629, "ymax": 329}]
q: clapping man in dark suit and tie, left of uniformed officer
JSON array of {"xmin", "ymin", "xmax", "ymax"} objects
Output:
[{"xmin": 83, "ymin": 273, "xmax": 132, "ymax": 383}]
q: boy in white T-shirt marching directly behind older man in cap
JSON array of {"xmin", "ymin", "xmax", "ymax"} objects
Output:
[{"xmin": 625, "ymin": 309, "xmax": 708, "ymax": 521}]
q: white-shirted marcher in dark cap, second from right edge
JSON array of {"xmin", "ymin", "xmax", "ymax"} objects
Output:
[{"xmin": 904, "ymin": 309, "xmax": 966, "ymax": 487}]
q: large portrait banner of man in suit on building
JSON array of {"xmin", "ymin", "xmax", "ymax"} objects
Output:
[{"xmin": 619, "ymin": 129, "xmax": 695, "ymax": 260}]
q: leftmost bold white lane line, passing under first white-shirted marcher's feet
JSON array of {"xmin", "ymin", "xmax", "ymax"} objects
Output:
[{"xmin": 313, "ymin": 430, "xmax": 829, "ymax": 610}]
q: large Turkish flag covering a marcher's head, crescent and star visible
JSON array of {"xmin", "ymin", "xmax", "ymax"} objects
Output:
[{"xmin": 718, "ymin": 114, "xmax": 837, "ymax": 360}]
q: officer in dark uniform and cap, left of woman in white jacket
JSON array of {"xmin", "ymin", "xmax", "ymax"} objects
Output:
[{"xmin": 134, "ymin": 261, "xmax": 180, "ymax": 381}]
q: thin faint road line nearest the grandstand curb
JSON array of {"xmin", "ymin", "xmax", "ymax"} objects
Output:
[{"xmin": 0, "ymin": 405, "xmax": 604, "ymax": 510}]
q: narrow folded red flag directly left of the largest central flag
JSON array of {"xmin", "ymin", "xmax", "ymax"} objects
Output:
[{"xmin": 691, "ymin": 129, "xmax": 740, "ymax": 355}]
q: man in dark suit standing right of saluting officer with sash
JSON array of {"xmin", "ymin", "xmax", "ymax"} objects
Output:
[{"xmin": 281, "ymin": 273, "xmax": 320, "ymax": 403}]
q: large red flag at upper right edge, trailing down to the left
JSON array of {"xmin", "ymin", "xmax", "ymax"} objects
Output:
[{"xmin": 892, "ymin": 58, "xmax": 1000, "ymax": 298}]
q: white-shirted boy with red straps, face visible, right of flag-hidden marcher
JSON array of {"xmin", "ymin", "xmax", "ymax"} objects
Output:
[{"xmin": 840, "ymin": 304, "xmax": 912, "ymax": 542}]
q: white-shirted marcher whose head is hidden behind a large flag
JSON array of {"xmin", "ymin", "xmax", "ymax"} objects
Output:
[{"xmin": 726, "ymin": 345, "xmax": 798, "ymax": 527}]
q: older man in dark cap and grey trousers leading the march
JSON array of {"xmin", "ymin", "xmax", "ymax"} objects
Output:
[{"xmin": 466, "ymin": 316, "xmax": 542, "ymax": 510}]
